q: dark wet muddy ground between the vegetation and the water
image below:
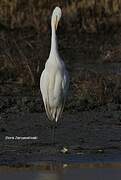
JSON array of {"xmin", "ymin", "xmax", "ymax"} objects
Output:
[{"xmin": 0, "ymin": 104, "xmax": 121, "ymax": 164}]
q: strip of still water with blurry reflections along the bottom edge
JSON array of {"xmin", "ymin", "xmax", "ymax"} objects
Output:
[{"xmin": 0, "ymin": 163, "xmax": 121, "ymax": 180}]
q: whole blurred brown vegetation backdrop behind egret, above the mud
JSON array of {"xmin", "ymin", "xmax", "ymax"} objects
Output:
[{"xmin": 0, "ymin": 0, "xmax": 121, "ymax": 112}]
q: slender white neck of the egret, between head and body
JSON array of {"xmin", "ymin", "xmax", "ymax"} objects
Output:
[{"xmin": 50, "ymin": 24, "xmax": 58, "ymax": 56}]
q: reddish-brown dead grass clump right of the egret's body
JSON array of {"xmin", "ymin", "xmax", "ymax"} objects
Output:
[{"xmin": 73, "ymin": 71, "xmax": 121, "ymax": 108}]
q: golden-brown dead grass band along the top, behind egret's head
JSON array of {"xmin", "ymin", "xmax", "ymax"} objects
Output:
[{"xmin": 0, "ymin": 0, "xmax": 121, "ymax": 32}]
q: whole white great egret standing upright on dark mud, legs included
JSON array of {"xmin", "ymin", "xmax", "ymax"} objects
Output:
[{"xmin": 40, "ymin": 7, "xmax": 69, "ymax": 141}]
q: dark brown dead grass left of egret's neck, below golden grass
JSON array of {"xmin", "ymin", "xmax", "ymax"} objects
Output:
[{"xmin": 0, "ymin": 30, "xmax": 46, "ymax": 86}]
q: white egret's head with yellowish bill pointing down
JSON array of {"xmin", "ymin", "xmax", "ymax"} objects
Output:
[{"xmin": 51, "ymin": 7, "xmax": 62, "ymax": 30}]
